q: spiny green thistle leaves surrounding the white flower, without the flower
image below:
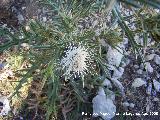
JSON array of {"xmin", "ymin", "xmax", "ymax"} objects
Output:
[{"xmin": 0, "ymin": 0, "xmax": 159, "ymax": 120}]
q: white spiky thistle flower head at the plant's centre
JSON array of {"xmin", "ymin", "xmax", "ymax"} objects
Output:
[{"xmin": 61, "ymin": 45, "xmax": 91, "ymax": 76}]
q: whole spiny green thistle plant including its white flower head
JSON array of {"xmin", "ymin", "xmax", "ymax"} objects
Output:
[{"xmin": 0, "ymin": 0, "xmax": 159, "ymax": 120}]
